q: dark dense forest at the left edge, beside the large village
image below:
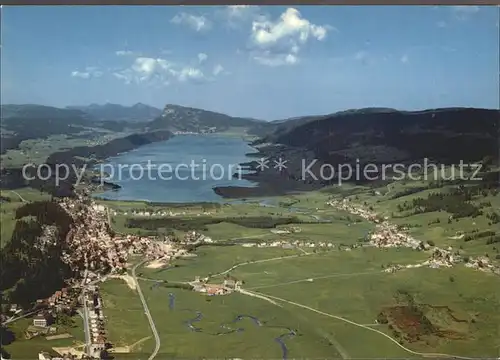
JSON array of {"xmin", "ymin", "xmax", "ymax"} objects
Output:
[{"xmin": 0, "ymin": 201, "xmax": 72, "ymax": 306}]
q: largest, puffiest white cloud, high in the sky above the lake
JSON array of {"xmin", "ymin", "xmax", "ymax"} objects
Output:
[{"xmin": 250, "ymin": 8, "xmax": 333, "ymax": 66}]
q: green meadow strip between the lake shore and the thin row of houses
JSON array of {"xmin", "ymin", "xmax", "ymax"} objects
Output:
[{"xmin": 104, "ymin": 193, "xmax": 373, "ymax": 243}]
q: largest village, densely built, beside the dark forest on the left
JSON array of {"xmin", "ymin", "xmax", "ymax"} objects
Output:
[{"xmin": 2, "ymin": 192, "xmax": 191, "ymax": 360}]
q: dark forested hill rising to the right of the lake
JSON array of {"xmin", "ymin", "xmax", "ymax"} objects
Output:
[{"xmin": 259, "ymin": 108, "xmax": 500, "ymax": 163}]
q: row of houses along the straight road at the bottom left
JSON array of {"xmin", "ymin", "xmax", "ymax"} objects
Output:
[{"xmin": 84, "ymin": 286, "xmax": 107, "ymax": 358}]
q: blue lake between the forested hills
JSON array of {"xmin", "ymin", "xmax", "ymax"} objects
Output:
[{"xmin": 98, "ymin": 135, "xmax": 257, "ymax": 203}]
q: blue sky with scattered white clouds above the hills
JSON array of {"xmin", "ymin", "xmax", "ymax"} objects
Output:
[{"xmin": 2, "ymin": 6, "xmax": 499, "ymax": 120}]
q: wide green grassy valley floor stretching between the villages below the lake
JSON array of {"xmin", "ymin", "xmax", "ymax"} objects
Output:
[{"xmin": 2, "ymin": 165, "xmax": 500, "ymax": 359}]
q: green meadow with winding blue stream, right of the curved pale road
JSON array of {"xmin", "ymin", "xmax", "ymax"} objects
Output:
[{"xmin": 142, "ymin": 284, "xmax": 346, "ymax": 359}]
